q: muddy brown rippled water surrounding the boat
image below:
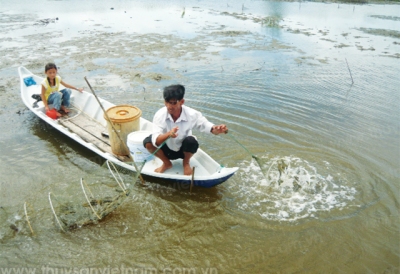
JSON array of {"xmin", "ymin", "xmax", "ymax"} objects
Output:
[{"xmin": 0, "ymin": 1, "xmax": 400, "ymax": 274}]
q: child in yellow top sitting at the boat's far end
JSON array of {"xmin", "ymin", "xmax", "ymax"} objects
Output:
[{"xmin": 41, "ymin": 63, "xmax": 83, "ymax": 117}]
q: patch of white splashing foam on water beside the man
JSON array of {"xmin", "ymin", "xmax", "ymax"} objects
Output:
[{"xmin": 233, "ymin": 156, "xmax": 357, "ymax": 221}]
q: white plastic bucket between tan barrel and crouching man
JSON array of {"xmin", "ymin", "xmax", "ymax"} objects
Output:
[{"xmin": 127, "ymin": 131, "xmax": 154, "ymax": 162}]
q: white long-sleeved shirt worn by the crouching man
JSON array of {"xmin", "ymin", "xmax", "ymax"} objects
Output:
[{"xmin": 151, "ymin": 105, "xmax": 214, "ymax": 151}]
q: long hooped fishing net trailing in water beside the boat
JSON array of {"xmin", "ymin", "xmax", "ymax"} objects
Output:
[{"xmin": 0, "ymin": 160, "xmax": 144, "ymax": 242}]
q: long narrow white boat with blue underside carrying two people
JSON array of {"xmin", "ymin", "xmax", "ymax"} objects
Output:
[{"xmin": 18, "ymin": 67, "xmax": 238, "ymax": 188}]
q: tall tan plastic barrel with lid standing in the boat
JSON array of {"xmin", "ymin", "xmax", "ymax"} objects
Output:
[{"xmin": 104, "ymin": 105, "xmax": 142, "ymax": 156}]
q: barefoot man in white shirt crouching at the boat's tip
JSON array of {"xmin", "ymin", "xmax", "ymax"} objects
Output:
[{"xmin": 143, "ymin": 85, "xmax": 228, "ymax": 175}]
